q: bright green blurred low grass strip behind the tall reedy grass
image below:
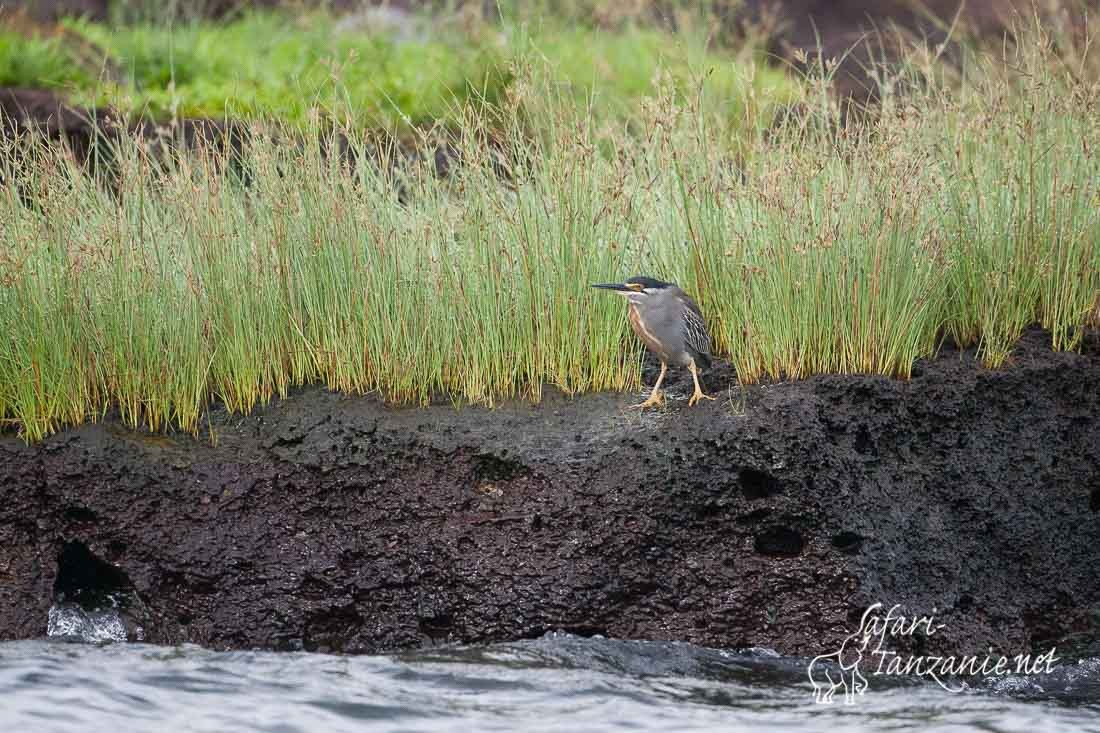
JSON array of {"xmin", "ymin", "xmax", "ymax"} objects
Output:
[{"xmin": 0, "ymin": 12, "xmax": 796, "ymax": 131}]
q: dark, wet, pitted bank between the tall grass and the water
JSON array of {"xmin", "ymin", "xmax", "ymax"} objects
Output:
[{"xmin": 0, "ymin": 332, "xmax": 1100, "ymax": 654}]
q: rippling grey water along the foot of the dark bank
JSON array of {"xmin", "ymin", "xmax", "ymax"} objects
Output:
[{"xmin": 0, "ymin": 634, "xmax": 1100, "ymax": 733}]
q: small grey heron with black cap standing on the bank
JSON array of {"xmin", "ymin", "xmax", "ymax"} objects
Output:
[{"xmin": 593, "ymin": 277, "xmax": 714, "ymax": 407}]
